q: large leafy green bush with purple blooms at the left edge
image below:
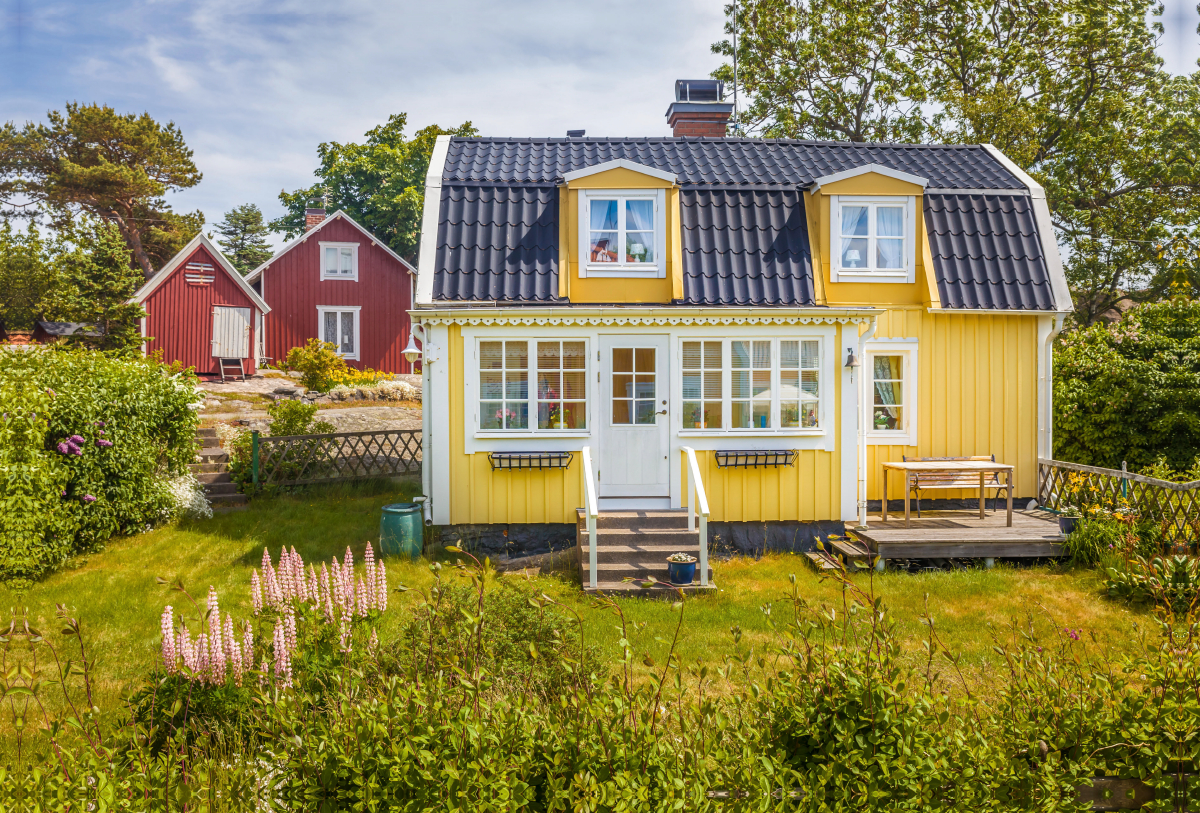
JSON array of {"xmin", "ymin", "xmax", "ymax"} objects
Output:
[{"xmin": 0, "ymin": 349, "xmax": 197, "ymax": 583}]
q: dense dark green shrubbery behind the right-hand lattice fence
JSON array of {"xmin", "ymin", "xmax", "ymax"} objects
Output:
[{"xmin": 1054, "ymin": 297, "xmax": 1200, "ymax": 471}]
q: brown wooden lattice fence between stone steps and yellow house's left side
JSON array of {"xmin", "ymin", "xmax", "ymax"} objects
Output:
[{"xmin": 252, "ymin": 429, "xmax": 421, "ymax": 487}]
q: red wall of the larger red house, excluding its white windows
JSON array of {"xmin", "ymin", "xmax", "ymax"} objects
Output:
[{"xmin": 259, "ymin": 218, "xmax": 413, "ymax": 373}]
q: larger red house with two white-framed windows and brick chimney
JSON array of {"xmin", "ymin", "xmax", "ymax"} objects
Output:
[{"xmin": 246, "ymin": 209, "xmax": 416, "ymax": 373}]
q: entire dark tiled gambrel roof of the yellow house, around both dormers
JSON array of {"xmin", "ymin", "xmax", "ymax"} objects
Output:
[{"xmin": 433, "ymin": 138, "xmax": 1054, "ymax": 309}]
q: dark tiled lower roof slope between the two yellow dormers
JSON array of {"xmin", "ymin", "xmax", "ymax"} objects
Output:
[{"xmin": 679, "ymin": 188, "xmax": 814, "ymax": 306}]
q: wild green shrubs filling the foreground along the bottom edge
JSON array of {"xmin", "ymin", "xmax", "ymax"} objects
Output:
[{"xmin": 0, "ymin": 558, "xmax": 1200, "ymax": 813}]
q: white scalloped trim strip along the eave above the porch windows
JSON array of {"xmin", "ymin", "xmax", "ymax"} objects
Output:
[{"xmin": 412, "ymin": 307, "xmax": 883, "ymax": 327}]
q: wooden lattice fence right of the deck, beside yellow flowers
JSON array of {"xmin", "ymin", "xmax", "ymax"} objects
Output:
[{"xmin": 1038, "ymin": 459, "xmax": 1200, "ymax": 544}]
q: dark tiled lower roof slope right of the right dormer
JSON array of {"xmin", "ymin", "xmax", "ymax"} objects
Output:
[{"xmin": 924, "ymin": 194, "xmax": 1055, "ymax": 311}]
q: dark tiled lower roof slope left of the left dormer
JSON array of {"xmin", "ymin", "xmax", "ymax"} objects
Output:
[{"xmin": 433, "ymin": 186, "xmax": 558, "ymax": 302}]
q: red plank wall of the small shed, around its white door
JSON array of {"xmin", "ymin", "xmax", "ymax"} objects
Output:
[{"xmin": 142, "ymin": 246, "xmax": 258, "ymax": 375}]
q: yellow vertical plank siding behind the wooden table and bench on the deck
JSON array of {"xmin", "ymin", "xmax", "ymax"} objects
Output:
[{"xmin": 864, "ymin": 308, "xmax": 1038, "ymax": 500}]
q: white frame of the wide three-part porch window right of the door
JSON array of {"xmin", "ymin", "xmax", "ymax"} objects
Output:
[{"xmin": 672, "ymin": 333, "xmax": 835, "ymax": 438}]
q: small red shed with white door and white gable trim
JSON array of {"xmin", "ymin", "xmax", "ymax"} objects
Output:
[{"xmin": 133, "ymin": 233, "xmax": 271, "ymax": 375}]
